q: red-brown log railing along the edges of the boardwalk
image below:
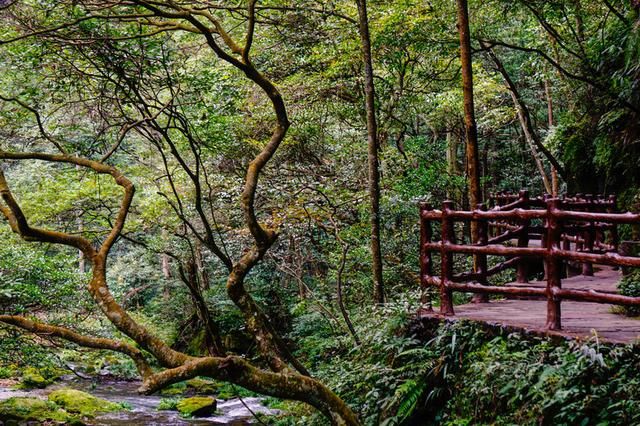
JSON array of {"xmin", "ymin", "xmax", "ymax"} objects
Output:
[{"xmin": 420, "ymin": 191, "xmax": 640, "ymax": 330}]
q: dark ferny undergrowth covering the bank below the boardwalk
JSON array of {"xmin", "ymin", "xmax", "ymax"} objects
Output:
[{"xmin": 272, "ymin": 296, "xmax": 640, "ymax": 426}]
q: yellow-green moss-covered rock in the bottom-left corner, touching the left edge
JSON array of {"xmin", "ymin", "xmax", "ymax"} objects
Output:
[{"xmin": 0, "ymin": 397, "xmax": 83, "ymax": 425}]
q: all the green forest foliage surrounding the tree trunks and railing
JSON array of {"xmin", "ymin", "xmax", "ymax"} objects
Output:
[{"xmin": 0, "ymin": 0, "xmax": 640, "ymax": 425}]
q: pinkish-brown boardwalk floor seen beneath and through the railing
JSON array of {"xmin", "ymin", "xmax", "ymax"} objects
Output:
[{"xmin": 421, "ymin": 267, "xmax": 640, "ymax": 343}]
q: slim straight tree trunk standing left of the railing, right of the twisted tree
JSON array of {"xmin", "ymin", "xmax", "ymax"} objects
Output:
[{"xmin": 356, "ymin": 0, "xmax": 384, "ymax": 304}]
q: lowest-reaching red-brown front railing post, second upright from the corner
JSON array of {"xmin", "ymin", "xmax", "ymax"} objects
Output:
[{"xmin": 545, "ymin": 198, "xmax": 562, "ymax": 330}]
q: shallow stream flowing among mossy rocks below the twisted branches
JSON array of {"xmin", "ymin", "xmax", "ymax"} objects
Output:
[{"xmin": 0, "ymin": 379, "xmax": 279, "ymax": 426}]
